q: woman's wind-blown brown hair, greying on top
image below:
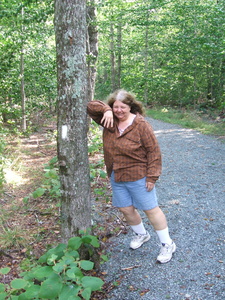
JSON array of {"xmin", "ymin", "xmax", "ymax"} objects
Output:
[{"xmin": 107, "ymin": 90, "xmax": 144, "ymax": 115}]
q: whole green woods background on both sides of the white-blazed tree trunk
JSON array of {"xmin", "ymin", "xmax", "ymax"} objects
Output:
[{"xmin": 0, "ymin": 0, "xmax": 225, "ymax": 130}]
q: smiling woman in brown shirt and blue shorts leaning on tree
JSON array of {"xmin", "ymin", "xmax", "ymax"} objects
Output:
[{"xmin": 87, "ymin": 90, "xmax": 176, "ymax": 263}]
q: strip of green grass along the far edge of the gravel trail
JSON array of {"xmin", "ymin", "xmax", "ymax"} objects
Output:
[{"xmin": 146, "ymin": 107, "xmax": 225, "ymax": 136}]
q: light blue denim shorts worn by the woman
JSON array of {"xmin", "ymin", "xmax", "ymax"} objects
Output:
[{"xmin": 110, "ymin": 172, "xmax": 158, "ymax": 210}]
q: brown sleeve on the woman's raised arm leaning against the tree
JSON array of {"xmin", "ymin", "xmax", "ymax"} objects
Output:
[{"xmin": 87, "ymin": 100, "xmax": 112, "ymax": 125}]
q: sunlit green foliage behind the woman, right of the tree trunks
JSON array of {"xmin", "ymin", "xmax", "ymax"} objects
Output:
[{"xmin": 96, "ymin": 0, "xmax": 225, "ymax": 109}]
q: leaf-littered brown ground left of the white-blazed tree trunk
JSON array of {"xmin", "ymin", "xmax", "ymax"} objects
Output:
[{"xmin": 0, "ymin": 127, "xmax": 59, "ymax": 282}]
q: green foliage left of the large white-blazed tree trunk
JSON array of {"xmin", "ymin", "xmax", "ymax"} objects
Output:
[{"xmin": 0, "ymin": 0, "xmax": 56, "ymax": 131}]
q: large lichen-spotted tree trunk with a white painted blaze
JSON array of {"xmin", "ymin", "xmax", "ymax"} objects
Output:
[{"xmin": 55, "ymin": 0, "xmax": 91, "ymax": 242}]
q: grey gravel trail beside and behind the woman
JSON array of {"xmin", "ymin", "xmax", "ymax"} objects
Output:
[{"xmin": 102, "ymin": 118, "xmax": 225, "ymax": 300}]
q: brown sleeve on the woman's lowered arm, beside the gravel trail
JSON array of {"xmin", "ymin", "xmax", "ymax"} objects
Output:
[{"xmin": 141, "ymin": 121, "xmax": 162, "ymax": 183}]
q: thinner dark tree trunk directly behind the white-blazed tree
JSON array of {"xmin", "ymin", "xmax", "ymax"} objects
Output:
[{"xmin": 87, "ymin": 0, "xmax": 98, "ymax": 101}]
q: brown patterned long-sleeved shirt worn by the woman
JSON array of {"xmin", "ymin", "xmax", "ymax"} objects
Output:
[{"xmin": 87, "ymin": 101, "xmax": 162, "ymax": 183}]
